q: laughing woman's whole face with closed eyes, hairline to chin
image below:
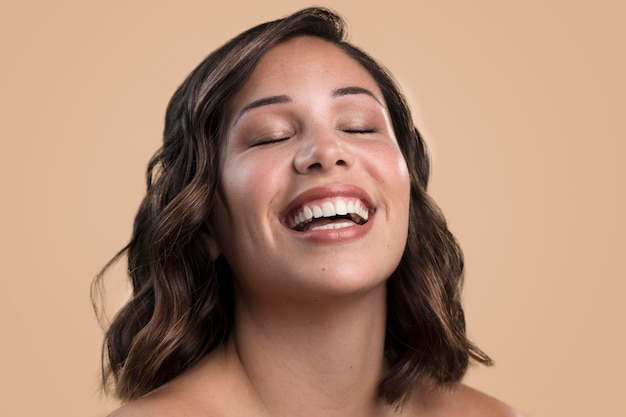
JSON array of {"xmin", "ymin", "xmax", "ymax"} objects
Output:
[{"xmin": 210, "ymin": 37, "xmax": 410, "ymax": 300}]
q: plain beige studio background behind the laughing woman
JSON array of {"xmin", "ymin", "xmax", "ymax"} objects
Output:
[{"xmin": 0, "ymin": 0, "xmax": 626, "ymax": 417}]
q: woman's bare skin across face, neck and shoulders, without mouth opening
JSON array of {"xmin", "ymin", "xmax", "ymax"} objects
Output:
[{"xmin": 106, "ymin": 37, "xmax": 517, "ymax": 417}]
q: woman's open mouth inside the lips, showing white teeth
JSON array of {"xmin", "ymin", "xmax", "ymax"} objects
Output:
[{"xmin": 287, "ymin": 197, "xmax": 369, "ymax": 232}]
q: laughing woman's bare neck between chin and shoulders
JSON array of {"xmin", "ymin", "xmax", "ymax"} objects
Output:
[{"xmin": 229, "ymin": 284, "xmax": 386, "ymax": 417}]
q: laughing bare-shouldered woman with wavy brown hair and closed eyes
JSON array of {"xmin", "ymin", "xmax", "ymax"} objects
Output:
[{"xmin": 96, "ymin": 8, "xmax": 513, "ymax": 417}]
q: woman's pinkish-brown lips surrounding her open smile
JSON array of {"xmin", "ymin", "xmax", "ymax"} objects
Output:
[{"xmin": 280, "ymin": 183, "xmax": 376, "ymax": 242}]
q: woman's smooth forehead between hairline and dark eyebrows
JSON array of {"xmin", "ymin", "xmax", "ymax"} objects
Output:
[{"xmin": 224, "ymin": 36, "xmax": 383, "ymax": 115}]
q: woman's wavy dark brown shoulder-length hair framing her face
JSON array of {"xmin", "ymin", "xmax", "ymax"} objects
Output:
[{"xmin": 94, "ymin": 8, "xmax": 491, "ymax": 405}]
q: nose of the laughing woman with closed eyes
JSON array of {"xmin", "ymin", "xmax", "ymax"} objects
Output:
[{"xmin": 294, "ymin": 132, "xmax": 354, "ymax": 174}]
